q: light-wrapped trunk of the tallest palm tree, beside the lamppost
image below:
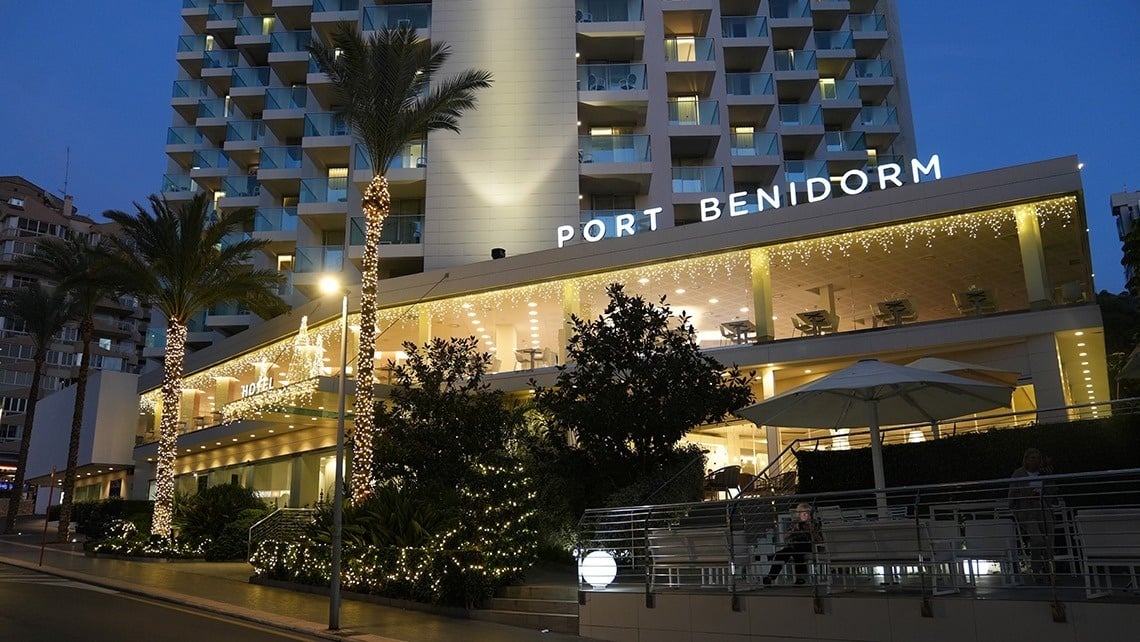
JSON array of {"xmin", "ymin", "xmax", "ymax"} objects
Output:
[{"xmin": 350, "ymin": 174, "xmax": 391, "ymax": 502}]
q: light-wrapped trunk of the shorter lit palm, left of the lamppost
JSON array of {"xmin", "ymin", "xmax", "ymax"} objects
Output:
[{"xmin": 150, "ymin": 319, "xmax": 187, "ymax": 537}]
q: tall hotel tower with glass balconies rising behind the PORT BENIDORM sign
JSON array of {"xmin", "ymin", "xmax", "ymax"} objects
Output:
[{"xmin": 158, "ymin": 0, "xmax": 915, "ymax": 358}]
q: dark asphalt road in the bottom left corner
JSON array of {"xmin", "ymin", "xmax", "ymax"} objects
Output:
[{"xmin": 0, "ymin": 564, "xmax": 317, "ymax": 642}]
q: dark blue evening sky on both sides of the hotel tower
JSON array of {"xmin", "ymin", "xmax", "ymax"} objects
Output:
[{"xmin": 0, "ymin": 0, "xmax": 1140, "ymax": 292}]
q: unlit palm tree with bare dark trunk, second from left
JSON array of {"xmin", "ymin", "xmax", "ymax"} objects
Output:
[{"xmin": 19, "ymin": 235, "xmax": 127, "ymax": 542}]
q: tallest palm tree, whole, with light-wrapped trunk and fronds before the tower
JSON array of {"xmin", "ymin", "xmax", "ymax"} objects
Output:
[{"xmin": 309, "ymin": 24, "xmax": 491, "ymax": 501}]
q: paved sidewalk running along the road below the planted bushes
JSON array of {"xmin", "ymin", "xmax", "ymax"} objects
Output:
[{"xmin": 0, "ymin": 518, "xmax": 587, "ymax": 642}]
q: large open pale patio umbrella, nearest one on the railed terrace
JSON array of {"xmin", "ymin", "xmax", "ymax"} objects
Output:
[{"xmin": 734, "ymin": 359, "xmax": 1013, "ymax": 504}]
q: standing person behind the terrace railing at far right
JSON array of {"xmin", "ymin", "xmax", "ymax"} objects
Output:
[{"xmin": 1009, "ymin": 448, "xmax": 1057, "ymax": 580}]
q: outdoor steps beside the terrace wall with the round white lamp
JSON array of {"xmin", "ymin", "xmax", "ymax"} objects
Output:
[{"xmin": 470, "ymin": 583, "xmax": 578, "ymax": 635}]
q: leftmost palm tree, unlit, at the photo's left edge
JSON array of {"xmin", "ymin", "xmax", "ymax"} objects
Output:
[{"xmin": 0, "ymin": 283, "xmax": 79, "ymax": 533}]
